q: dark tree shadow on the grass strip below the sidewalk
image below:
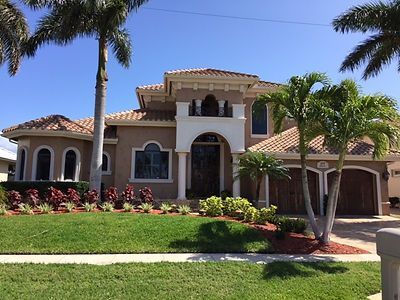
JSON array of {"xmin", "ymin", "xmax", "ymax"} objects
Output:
[{"xmin": 263, "ymin": 262, "xmax": 349, "ymax": 279}]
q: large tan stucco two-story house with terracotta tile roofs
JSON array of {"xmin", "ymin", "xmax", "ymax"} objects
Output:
[{"xmin": 3, "ymin": 69, "xmax": 400, "ymax": 215}]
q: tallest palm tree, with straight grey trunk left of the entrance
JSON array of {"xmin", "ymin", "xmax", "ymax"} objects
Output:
[{"xmin": 25, "ymin": 0, "xmax": 148, "ymax": 191}]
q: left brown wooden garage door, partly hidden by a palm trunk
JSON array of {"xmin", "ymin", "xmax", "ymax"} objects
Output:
[{"xmin": 269, "ymin": 168, "xmax": 319, "ymax": 214}]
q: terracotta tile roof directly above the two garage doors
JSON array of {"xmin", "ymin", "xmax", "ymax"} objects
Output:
[{"xmin": 249, "ymin": 127, "xmax": 400, "ymax": 156}]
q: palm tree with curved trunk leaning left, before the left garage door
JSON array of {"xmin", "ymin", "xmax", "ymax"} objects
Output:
[{"xmin": 255, "ymin": 73, "xmax": 329, "ymax": 239}]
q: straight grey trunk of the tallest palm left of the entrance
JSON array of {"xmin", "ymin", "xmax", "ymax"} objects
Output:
[{"xmin": 90, "ymin": 37, "xmax": 108, "ymax": 192}]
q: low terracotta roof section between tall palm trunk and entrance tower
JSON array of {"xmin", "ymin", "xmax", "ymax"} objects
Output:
[{"xmin": 106, "ymin": 108, "xmax": 175, "ymax": 121}]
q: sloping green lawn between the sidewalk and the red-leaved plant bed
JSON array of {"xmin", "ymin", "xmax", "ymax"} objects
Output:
[{"xmin": 0, "ymin": 213, "xmax": 272, "ymax": 254}]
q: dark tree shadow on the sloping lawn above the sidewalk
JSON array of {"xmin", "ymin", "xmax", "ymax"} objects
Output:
[{"xmin": 169, "ymin": 220, "xmax": 272, "ymax": 253}]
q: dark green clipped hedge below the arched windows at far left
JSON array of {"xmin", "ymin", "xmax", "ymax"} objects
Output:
[{"xmin": 0, "ymin": 181, "xmax": 89, "ymax": 198}]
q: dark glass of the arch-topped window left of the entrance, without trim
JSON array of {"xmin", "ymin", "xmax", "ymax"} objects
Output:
[{"xmin": 134, "ymin": 143, "xmax": 170, "ymax": 179}]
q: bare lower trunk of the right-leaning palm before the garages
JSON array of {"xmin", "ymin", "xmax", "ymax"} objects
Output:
[{"xmin": 322, "ymin": 150, "xmax": 346, "ymax": 244}]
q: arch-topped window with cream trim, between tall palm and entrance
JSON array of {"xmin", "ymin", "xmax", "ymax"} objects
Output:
[{"xmin": 131, "ymin": 142, "xmax": 172, "ymax": 183}]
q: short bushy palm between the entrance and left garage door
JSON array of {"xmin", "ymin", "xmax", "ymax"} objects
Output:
[{"xmin": 236, "ymin": 152, "xmax": 290, "ymax": 202}]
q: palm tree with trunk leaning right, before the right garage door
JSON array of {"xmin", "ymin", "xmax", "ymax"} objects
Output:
[{"xmin": 313, "ymin": 80, "xmax": 400, "ymax": 243}]
